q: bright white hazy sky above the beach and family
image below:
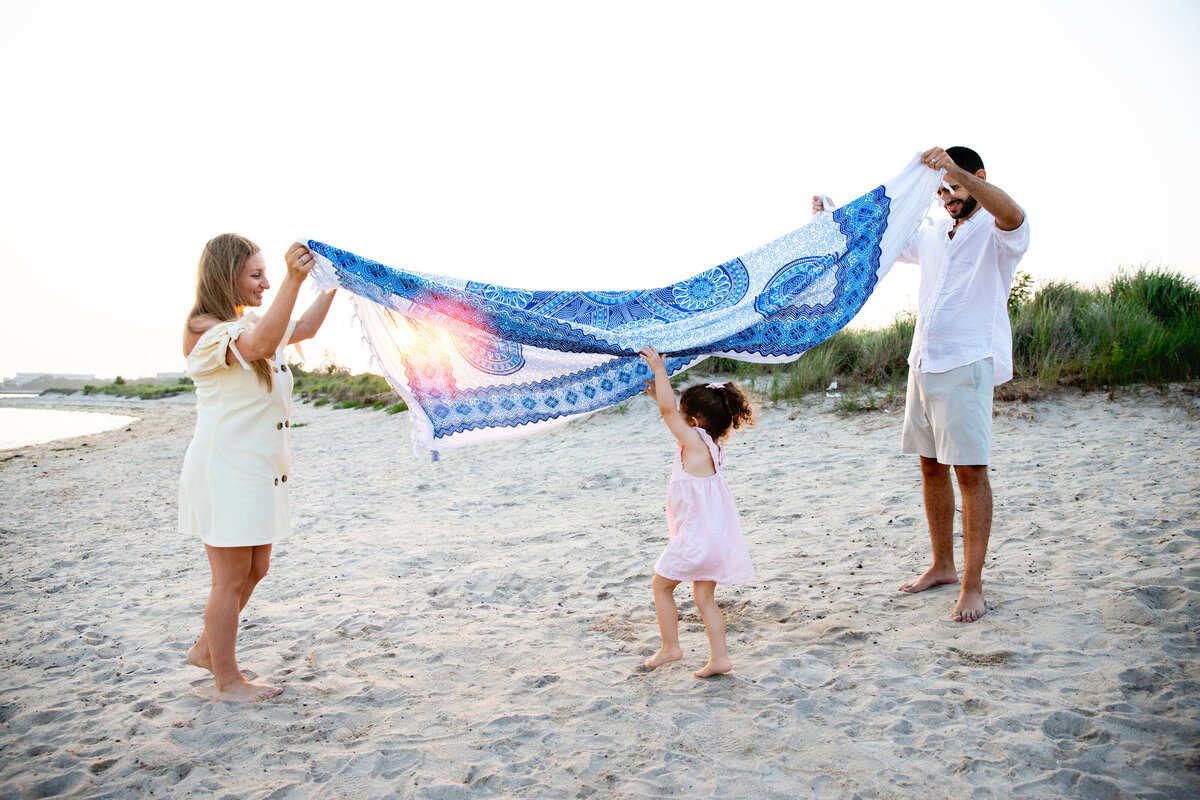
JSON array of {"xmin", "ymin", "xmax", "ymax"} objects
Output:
[{"xmin": 0, "ymin": 0, "xmax": 1200, "ymax": 377}]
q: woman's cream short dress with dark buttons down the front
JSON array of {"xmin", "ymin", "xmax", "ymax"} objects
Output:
[{"xmin": 179, "ymin": 314, "xmax": 295, "ymax": 547}]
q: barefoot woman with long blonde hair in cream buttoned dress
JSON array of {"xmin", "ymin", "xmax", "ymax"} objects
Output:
[{"xmin": 179, "ymin": 234, "xmax": 334, "ymax": 703}]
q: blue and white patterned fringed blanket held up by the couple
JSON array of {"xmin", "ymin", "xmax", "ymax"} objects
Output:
[{"xmin": 301, "ymin": 160, "xmax": 940, "ymax": 457}]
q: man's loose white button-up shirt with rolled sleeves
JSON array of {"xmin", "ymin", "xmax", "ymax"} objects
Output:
[{"xmin": 899, "ymin": 207, "xmax": 1030, "ymax": 386}]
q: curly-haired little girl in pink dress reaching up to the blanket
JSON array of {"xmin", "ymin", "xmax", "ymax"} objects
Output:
[{"xmin": 641, "ymin": 347, "xmax": 754, "ymax": 678}]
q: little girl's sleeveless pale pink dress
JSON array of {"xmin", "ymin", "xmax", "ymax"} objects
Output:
[{"xmin": 654, "ymin": 428, "xmax": 754, "ymax": 584}]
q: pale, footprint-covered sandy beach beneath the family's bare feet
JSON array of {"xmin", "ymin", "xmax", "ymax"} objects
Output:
[{"xmin": 0, "ymin": 387, "xmax": 1200, "ymax": 800}]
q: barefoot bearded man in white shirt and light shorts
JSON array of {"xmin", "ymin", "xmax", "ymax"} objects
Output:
[{"xmin": 812, "ymin": 148, "xmax": 1030, "ymax": 622}]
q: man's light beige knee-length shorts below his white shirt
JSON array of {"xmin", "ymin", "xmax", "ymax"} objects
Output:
[{"xmin": 900, "ymin": 359, "xmax": 994, "ymax": 467}]
